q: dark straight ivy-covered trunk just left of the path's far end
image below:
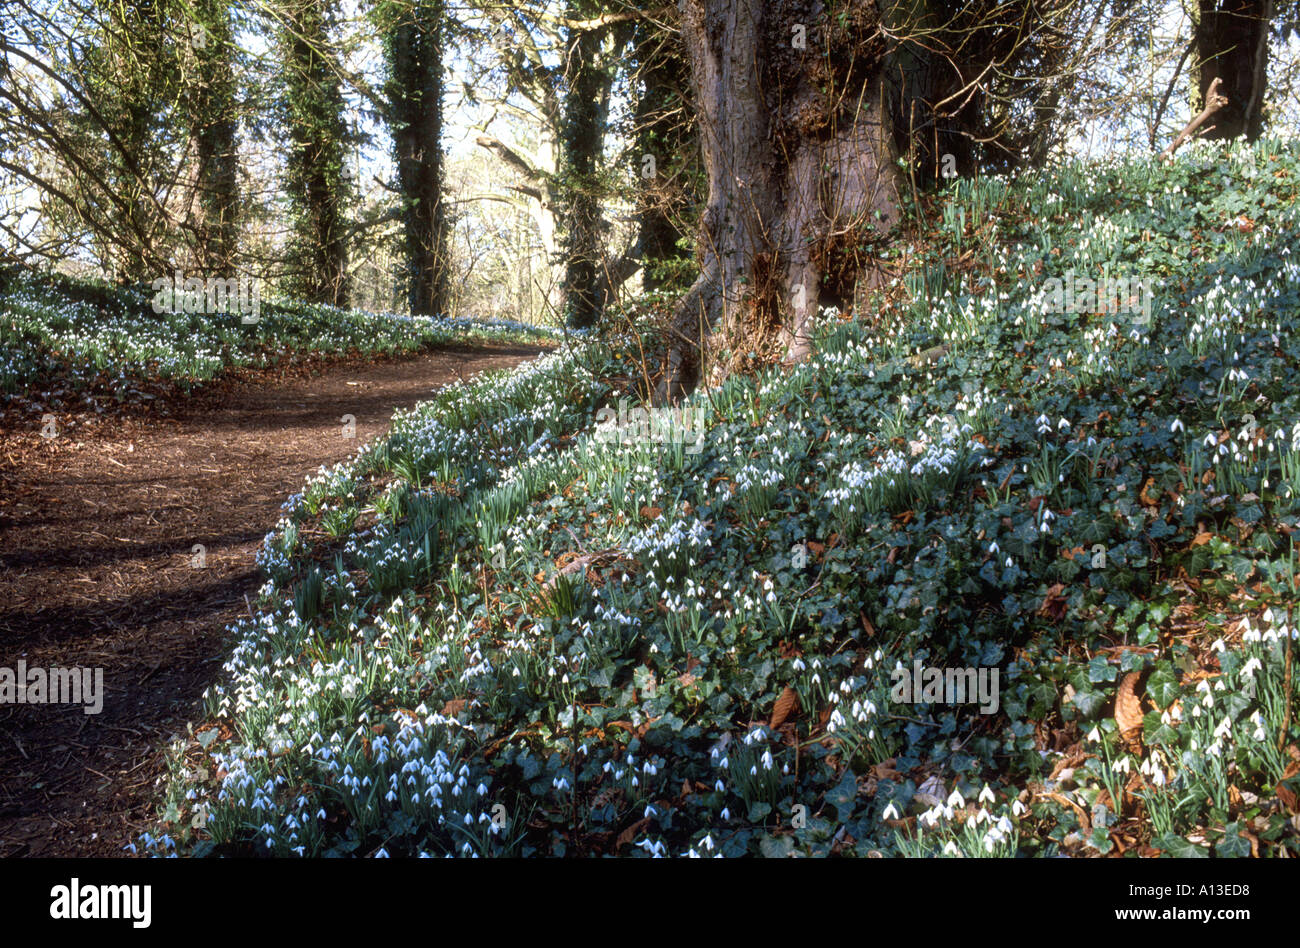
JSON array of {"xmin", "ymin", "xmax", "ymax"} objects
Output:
[{"xmin": 386, "ymin": 0, "xmax": 447, "ymax": 316}]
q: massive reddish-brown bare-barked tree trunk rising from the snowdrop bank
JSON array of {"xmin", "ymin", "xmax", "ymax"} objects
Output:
[{"xmin": 660, "ymin": 0, "xmax": 902, "ymax": 399}]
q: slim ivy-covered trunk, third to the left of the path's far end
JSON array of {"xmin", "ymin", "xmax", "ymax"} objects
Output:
[{"xmin": 190, "ymin": 0, "xmax": 239, "ymax": 276}]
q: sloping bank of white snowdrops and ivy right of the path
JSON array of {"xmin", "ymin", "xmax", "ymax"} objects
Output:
[{"xmin": 146, "ymin": 140, "xmax": 1300, "ymax": 856}]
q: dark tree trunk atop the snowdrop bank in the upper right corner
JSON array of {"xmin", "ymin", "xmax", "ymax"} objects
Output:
[{"xmin": 1196, "ymin": 0, "xmax": 1273, "ymax": 142}]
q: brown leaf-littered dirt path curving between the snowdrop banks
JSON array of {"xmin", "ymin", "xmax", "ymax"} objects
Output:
[{"xmin": 0, "ymin": 346, "xmax": 540, "ymax": 857}]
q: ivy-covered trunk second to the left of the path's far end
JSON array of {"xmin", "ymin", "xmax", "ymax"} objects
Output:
[{"xmin": 282, "ymin": 0, "xmax": 350, "ymax": 307}]
